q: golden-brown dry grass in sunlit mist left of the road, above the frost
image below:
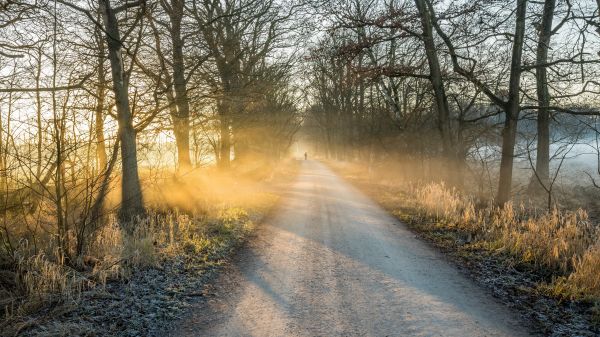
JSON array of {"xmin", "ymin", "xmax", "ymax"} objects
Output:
[{"xmin": 0, "ymin": 159, "xmax": 295, "ymax": 328}]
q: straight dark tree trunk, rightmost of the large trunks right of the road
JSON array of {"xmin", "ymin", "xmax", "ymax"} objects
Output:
[{"xmin": 531, "ymin": 0, "xmax": 556, "ymax": 189}]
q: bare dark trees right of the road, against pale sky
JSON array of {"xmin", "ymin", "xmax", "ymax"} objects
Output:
[{"xmin": 307, "ymin": 0, "xmax": 600, "ymax": 204}]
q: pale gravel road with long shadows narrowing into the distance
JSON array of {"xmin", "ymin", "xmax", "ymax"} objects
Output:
[{"xmin": 171, "ymin": 161, "xmax": 527, "ymax": 337}]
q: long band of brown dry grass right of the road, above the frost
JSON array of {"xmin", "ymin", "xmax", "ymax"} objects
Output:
[{"xmin": 333, "ymin": 160, "xmax": 600, "ymax": 301}]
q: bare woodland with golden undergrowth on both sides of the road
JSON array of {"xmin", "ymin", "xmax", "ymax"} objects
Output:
[{"xmin": 0, "ymin": 0, "xmax": 600, "ymax": 334}]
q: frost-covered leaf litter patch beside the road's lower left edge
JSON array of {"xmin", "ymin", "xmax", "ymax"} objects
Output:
[{"xmin": 18, "ymin": 253, "xmax": 220, "ymax": 336}]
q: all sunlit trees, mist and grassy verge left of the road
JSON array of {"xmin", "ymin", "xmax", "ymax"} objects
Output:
[{"xmin": 0, "ymin": 0, "xmax": 306, "ymax": 336}]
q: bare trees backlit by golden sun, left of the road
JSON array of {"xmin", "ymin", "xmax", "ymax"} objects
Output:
[{"xmin": 0, "ymin": 0, "xmax": 304, "ymax": 257}]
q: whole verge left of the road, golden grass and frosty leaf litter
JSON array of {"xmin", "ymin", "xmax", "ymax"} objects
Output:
[{"xmin": 0, "ymin": 159, "xmax": 295, "ymax": 336}]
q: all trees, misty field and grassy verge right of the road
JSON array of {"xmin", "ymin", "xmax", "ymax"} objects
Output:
[{"xmin": 301, "ymin": 0, "xmax": 600, "ymax": 330}]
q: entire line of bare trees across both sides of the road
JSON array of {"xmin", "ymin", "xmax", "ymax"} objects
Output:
[{"xmin": 0, "ymin": 0, "xmax": 600, "ymax": 262}]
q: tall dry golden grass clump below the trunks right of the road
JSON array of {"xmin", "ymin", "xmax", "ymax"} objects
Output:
[{"xmin": 400, "ymin": 183, "xmax": 598, "ymax": 274}]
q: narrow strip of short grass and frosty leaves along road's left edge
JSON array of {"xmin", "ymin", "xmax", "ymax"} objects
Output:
[{"xmin": 1, "ymin": 207, "xmax": 274, "ymax": 336}]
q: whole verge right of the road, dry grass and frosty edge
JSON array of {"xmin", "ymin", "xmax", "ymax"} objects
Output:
[{"xmin": 331, "ymin": 160, "xmax": 600, "ymax": 336}]
